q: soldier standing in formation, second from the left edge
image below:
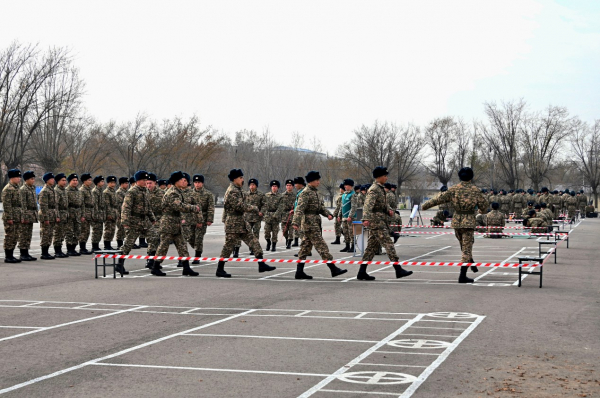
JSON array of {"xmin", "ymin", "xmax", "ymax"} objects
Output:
[{"xmin": 19, "ymin": 171, "xmax": 38, "ymax": 261}]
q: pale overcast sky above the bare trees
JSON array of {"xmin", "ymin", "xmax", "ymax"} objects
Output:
[{"xmin": 0, "ymin": 0, "xmax": 600, "ymax": 152}]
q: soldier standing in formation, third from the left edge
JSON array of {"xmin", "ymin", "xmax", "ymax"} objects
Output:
[{"xmin": 38, "ymin": 173, "xmax": 60, "ymax": 260}]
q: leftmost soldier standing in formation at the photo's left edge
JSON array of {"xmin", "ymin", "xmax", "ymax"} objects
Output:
[{"xmin": 2, "ymin": 169, "xmax": 22, "ymax": 263}]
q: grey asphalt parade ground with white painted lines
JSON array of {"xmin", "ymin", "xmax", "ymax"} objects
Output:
[{"xmin": 0, "ymin": 209, "xmax": 600, "ymax": 398}]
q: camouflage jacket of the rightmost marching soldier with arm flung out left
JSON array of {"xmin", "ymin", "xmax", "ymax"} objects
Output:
[{"xmin": 423, "ymin": 181, "xmax": 488, "ymax": 228}]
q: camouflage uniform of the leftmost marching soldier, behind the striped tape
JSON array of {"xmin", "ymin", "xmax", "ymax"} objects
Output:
[{"xmin": 121, "ymin": 184, "xmax": 156, "ymax": 254}]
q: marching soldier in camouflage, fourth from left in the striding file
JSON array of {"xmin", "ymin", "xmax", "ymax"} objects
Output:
[{"xmin": 292, "ymin": 171, "xmax": 348, "ymax": 279}]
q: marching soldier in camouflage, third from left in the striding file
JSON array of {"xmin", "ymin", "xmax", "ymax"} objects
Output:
[{"xmin": 216, "ymin": 169, "xmax": 275, "ymax": 278}]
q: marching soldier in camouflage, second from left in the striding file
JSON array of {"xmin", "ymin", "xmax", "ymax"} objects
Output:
[{"xmin": 146, "ymin": 171, "xmax": 202, "ymax": 276}]
